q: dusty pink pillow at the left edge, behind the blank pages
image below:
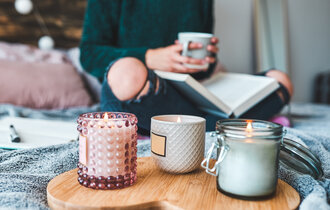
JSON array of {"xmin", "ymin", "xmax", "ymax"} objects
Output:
[{"xmin": 0, "ymin": 59, "xmax": 92, "ymax": 109}]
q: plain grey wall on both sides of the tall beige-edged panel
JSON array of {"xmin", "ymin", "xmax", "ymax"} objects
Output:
[{"xmin": 214, "ymin": 0, "xmax": 330, "ymax": 102}]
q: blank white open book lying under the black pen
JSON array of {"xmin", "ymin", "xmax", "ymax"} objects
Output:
[{"xmin": 0, "ymin": 117, "xmax": 78, "ymax": 149}]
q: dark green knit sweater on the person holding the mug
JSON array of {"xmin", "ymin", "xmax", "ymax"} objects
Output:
[{"xmin": 80, "ymin": 0, "xmax": 213, "ymax": 80}]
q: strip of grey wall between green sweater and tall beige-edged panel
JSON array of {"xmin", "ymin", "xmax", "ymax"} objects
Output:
[{"xmin": 214, "ymin": 0, "xmax": 255, "ymax": 73}]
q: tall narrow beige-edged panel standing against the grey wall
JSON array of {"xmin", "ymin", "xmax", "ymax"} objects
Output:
[{"xmin": 254, "ymin": 0, "xmax": 290, "ymax": 72}]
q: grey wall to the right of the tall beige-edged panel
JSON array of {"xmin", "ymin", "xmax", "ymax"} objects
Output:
[{"xmin": 288, "ymin": 0, "xmax": 330, "ymax": 102}]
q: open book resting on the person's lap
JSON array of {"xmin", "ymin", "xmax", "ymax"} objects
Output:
[{"xmin": 155, "ymin": 71, "xmax": 279, "ymax": 118}]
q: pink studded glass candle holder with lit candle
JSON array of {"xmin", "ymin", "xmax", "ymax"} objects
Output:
[{"xmin": 77, "ymin": 112, "xmax": 137, "ymax": 190}]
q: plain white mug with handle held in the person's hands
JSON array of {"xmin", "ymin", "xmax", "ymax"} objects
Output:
[{"xmin": 178, "ymin": 32, "xmax": 213, "ymax": 69}]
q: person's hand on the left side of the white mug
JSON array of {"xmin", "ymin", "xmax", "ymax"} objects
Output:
[{"xmin": 146, "ymin": 43, "xmax": 206, "ymax": 73}]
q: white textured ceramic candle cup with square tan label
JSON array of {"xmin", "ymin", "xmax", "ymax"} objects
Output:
[{"xmin": 150, "ymin": 115, "xmax": 205, "ymax": 173}]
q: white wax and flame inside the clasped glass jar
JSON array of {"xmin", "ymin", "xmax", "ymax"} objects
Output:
[{"xmin": 218, "ymin": 121, "xmax": 280, "ymax": 196}]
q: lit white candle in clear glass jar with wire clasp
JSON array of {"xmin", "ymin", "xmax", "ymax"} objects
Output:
[{"xmin": 202, "ymin": 119, "xmax": 283, "ymax": 198}]
